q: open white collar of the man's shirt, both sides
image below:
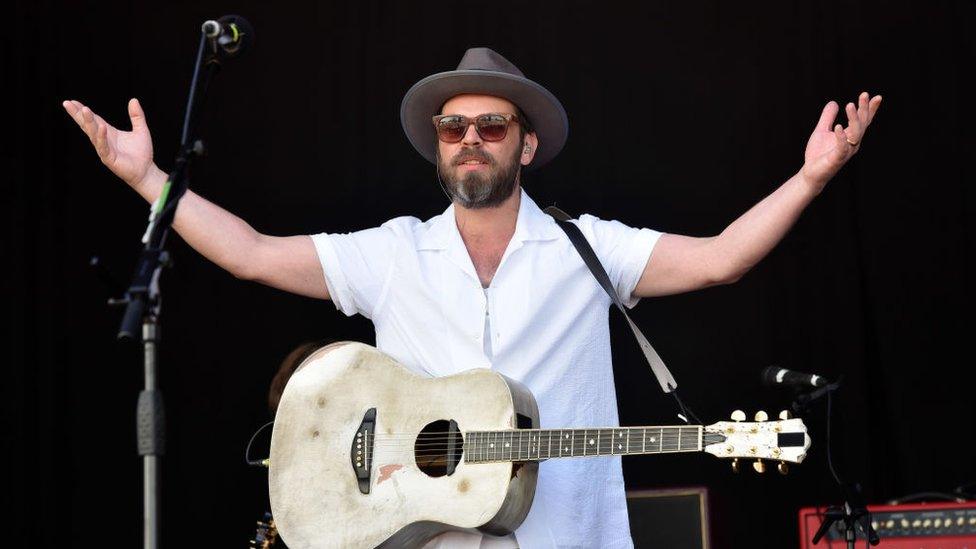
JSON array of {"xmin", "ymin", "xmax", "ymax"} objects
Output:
[{"xmin": 417, "ymin": 189, "xmax": 562, "ymax": 250}]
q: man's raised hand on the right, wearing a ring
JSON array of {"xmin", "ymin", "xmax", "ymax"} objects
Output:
[{"xmin": 800, "ymin": 92, "xmax": 881, "ymax": 193}]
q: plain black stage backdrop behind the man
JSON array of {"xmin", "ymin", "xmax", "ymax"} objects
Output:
[{"xmin": 7, "ymin": 0, "xmax": 976, "ymax": 547}]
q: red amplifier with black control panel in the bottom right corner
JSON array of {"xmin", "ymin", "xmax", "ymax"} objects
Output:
[{"xmin": 800, "ymin": 501, "xmax": 976, "ymax": 549}]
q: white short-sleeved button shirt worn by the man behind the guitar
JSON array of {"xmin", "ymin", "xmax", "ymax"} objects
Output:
[{"xmin": 312, "ymin": 190, "xmax": 661, "ymax": 549}]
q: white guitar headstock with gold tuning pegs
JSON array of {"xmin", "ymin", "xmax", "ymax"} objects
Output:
[{"xmin": 702, "ymin": 410, "xmax": 810, "ymax": 475}]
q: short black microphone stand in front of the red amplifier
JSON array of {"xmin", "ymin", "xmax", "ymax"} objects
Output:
[{"xmin": 792, "ymin": 380, "xmax": 881, "ymax": 549}]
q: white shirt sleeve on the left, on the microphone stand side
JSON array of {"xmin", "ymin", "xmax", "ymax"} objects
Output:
[{"xmin": 312, "ymin": 224, "xmax": 397, "ymax": 319}]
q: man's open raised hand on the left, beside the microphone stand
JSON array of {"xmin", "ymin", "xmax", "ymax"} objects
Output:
[{"xmin": 62, "ymin": 99, "xmax": 165, "ymax": 200}]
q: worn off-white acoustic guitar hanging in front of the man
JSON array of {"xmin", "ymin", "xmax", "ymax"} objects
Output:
[{"xmin": 269, "ymin": 342, "xmax": 810, "ymax": 548}]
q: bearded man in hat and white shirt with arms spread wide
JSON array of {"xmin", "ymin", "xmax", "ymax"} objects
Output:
[{"xmin": 64, "ymin": 48, "xmax": 881, "ymax": 548}]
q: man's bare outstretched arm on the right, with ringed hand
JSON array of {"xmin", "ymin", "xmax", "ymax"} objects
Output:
[{"xmin": 634, "ymin": 92, "xmax": 881, "ymax": 297}]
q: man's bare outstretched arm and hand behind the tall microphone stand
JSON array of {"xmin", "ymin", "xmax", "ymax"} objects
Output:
[{"xmin": 62, "ymin": 99, "xmax": 329, "ymax": 299}]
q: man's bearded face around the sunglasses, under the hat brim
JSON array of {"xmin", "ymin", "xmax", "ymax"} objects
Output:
[{"xmin": 437, "ymin": 95, "xmax": 534, "ymax": 209}]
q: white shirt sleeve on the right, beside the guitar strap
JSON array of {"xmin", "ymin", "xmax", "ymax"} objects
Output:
[{"xmin": 577, "ymin": 214, "xmax": 662, "ymax": 308}]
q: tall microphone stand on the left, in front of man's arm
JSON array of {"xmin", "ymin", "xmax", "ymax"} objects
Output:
[{"xmin": 109, "ymin": 22, "xmax": 226, "ymax": 549}]
